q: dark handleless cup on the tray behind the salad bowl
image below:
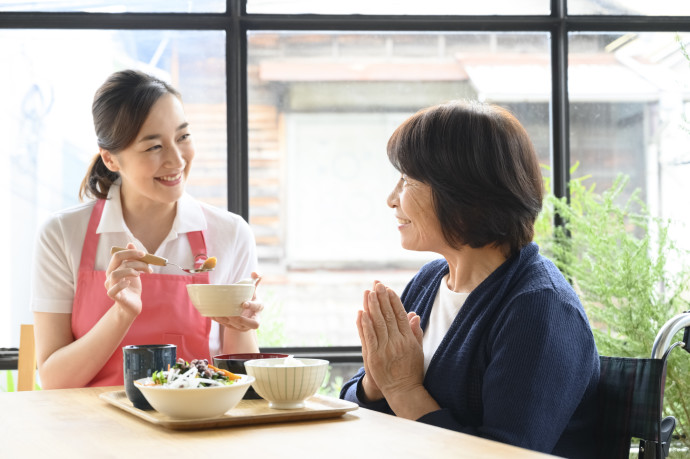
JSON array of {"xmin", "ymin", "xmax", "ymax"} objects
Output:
[{"xmin": 122, "ymin": 344, "xmax": 177, "ymax": 410}]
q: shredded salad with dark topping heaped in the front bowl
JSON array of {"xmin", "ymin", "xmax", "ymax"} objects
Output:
[{"xmin": 137, "ymin": 359, "xmax": 241, "ymax": 389}]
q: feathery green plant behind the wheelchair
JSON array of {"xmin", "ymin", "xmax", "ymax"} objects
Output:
[{"xmin": 535, "ymin": 169, "xmax": 690, "ymax": 448}]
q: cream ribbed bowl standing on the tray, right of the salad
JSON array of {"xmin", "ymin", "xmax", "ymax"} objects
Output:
[{"xmin": 244, "ymin": 358, "xmax": 329, "ymax": 409}]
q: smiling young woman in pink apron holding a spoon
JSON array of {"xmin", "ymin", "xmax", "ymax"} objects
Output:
[{"xmin": 31, "ymin": 70, "xmax": 263, "ymax": 389}]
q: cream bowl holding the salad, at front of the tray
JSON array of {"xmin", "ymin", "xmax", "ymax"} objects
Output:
[{"xmin": 134, "ymin": 375, "xmax": 254, "ymax": 419}]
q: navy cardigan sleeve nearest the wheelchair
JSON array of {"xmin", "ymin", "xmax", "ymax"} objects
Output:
[{"xmin": 418, "ymin": 291, "xmax": 599, "ymax": 452}]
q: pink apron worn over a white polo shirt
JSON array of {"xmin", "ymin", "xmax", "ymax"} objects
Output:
[{"xmin": 72, "ymin": 199, "xmax": 211, "ymax": 386}]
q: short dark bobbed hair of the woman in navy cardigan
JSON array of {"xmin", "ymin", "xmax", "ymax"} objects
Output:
[{"xmin": 388, "ymin": 101, "xmax": 543, "ymax": 255}]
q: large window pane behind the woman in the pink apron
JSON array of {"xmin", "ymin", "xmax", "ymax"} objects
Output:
[{"xmin": 0, "ymin": 30, "xmax": 227, "ymax": 347}]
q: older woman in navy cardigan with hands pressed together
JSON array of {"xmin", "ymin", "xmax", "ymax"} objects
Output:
[{"xmin": 341, "ymin": 102, "xmax": 599, "ymax": 457}]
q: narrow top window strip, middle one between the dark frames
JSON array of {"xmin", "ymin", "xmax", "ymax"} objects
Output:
[{"xmin": 247, "ymin": 0, "xmax": 551, "ymax": 15}]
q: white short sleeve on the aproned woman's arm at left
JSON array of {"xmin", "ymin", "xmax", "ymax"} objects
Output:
[{"xmin": 31, "ymin": 215, "xmax": 81, "ymax": 313}]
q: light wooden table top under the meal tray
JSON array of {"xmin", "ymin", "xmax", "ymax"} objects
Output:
[{"xmin": 0, "ymin": 387, "xmax": 552, "ymax": 459}]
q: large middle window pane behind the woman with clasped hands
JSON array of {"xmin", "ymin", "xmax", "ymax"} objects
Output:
[{"xmin": 248, "ymin": 31, "xmax": 551, "ymax": 346}]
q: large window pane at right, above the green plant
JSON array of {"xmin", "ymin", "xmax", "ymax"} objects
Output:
[{"xmin": 569, "ymin": 33, "xmax": 690, "ymax": 245}]
